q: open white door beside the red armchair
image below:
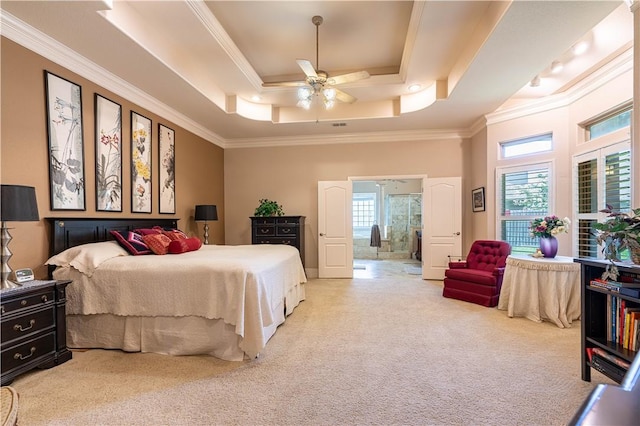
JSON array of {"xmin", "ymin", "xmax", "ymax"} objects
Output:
[{"xmin": 422, "ymin": 177, "xmax": 462, "ymax": 280}]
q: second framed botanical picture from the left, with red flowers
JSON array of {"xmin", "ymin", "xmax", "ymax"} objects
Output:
[{"xmin": 95, "ymin": 93, "xmax": 122, "ymax": 212}]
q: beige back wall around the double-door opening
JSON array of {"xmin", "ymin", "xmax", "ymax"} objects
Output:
[{"xmin": 224, "ymin": 137, "xmax": 468, "ymax": 268}]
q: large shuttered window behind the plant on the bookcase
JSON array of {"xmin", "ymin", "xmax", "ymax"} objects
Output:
[{"xmin": 574, "ymin": 142, "xmax": 632, "ymax": 259}]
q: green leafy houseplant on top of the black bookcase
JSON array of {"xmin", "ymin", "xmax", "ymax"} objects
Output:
[{"xmin": 593, "ymin": 205, "xmax": 640, "ymax": 264}]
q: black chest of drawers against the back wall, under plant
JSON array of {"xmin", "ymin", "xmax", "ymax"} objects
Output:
[{"xmin": 251, "ymin": 216, "xmax": 305, "ymax": 266}]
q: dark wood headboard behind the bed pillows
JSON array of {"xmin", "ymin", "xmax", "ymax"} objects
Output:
[{"xmin": 47, "ymin": 217, "xmax": 178, "ymax": 256}]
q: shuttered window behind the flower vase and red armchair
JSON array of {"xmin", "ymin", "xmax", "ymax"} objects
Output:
[{"xmin": 496, "ymin": 163, "xmax": 551, "ymax": 254}]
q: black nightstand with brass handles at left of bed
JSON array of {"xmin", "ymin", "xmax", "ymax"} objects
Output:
[{"xmin": 0, "ymin": 280, "xmax": 71, "ymax": 386}]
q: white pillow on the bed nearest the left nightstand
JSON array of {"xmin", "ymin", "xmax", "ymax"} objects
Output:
[{"xmin": 45, "ymin": 241, "xmax": 129, "ymax": 276}]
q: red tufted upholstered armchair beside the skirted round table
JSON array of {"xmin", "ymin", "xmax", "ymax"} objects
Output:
[{"xmin": 442, "ymin": 240, "xmax": 511, "ymax": 306}]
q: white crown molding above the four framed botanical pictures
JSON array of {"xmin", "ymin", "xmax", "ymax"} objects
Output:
[{"xmin": 0, "ymin": 11, "xmax": 227, "ymax": 148}]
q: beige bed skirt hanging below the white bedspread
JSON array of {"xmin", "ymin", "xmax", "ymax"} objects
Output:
[{"xmin": 67, "ymin": 284, "xmax": 305, "ymax": 361}]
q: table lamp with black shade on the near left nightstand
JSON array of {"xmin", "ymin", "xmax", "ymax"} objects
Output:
[{"xmin": 0, "ymin": 185, "xmax": 40, "ymax": 289}]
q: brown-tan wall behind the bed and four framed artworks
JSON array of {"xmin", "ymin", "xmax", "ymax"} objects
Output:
[{"xmin": 0, "ymin": 37, "xmax": 225, "ymax": 278}]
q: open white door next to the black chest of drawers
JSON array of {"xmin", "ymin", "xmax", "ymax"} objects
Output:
[{"xmin": 318, "ymin": 181, "xmax": 353, "ymax": 278}]
